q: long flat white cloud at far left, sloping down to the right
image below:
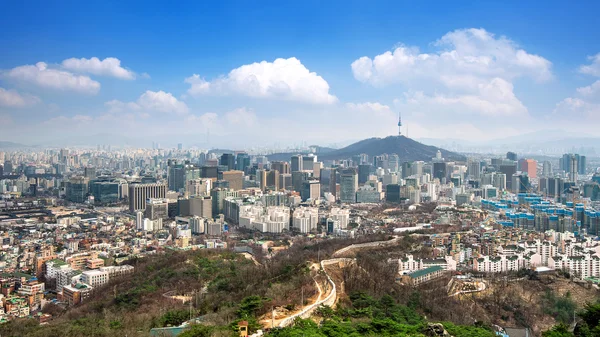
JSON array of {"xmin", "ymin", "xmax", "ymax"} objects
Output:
[{"xmin": 6, "ymin": 62, "xmax": 100, "ymax": 94}]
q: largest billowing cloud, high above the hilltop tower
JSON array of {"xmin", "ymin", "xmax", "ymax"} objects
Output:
[{"xmin": 351, "ymin": 29, "xmax": 552, "ymax": 87}]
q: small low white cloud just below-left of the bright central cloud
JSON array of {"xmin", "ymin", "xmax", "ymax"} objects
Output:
[{"xmin": 104, "ymin": 90, "xmax": 189, "ymax": 117}]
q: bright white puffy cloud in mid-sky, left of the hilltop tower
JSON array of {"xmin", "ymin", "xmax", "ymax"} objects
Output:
[{"xmin": 185, "ymin": 57, "xmax": 337, "ymax": 104}]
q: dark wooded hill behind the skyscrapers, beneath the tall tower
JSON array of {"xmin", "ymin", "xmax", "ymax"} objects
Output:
[{"xmin": 268, "ymin": 136, "xmax": 466, "ymax": 161}]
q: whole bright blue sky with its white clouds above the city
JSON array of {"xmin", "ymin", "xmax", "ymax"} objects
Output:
[{"xmin": 0, "ymin": 1, "xmax": 600, "ymax": 146}]
